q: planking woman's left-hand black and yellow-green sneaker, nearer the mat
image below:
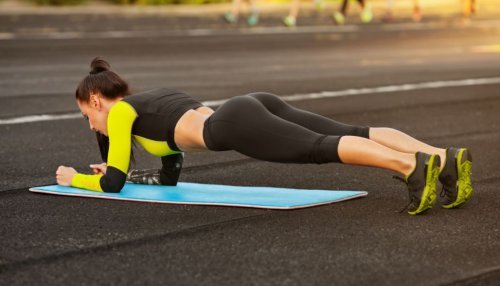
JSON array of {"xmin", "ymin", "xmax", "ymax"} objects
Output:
[{"xmin": 394, "ymin": 152, "xmax": 441, "ymax": 215}]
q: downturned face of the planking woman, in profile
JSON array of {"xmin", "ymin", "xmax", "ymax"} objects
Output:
[{"xmin": 76, "ymin": 94, "xmax": 108, "ymax": 136}]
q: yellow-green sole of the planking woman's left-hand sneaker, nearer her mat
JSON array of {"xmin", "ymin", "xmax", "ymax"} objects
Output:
[{"xmin": 408, "ymin": 155, "xmax": 441, "ymax": 215}]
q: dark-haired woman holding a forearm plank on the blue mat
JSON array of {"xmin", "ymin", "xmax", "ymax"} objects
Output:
[{"xmin": 56, "ymin": 58, "xmax": 473, "ymax": 214}]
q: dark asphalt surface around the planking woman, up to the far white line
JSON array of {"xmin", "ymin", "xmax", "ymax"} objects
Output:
[{"xmin": 0, "ymin": 12, "xmax": 500, "ymax": 285}]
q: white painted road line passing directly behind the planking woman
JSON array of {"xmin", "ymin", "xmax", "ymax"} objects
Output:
[{"xmin": 0, "ymin": 77, "xmax": 500, "ymax": 125}]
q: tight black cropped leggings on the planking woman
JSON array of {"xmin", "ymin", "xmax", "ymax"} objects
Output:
[{"xmin": 203, "ymin": 92, "xmax": 369, "ymax": 164}]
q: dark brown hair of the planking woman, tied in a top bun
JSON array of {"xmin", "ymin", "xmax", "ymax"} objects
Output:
[{"xmin": 75, "ymin": 57, "xmax": 130, "ymax": 102}]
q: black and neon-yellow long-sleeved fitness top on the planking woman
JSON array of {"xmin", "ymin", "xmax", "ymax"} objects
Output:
[{"xmin": 71, "ymin": 88, "xmax": 203, "ymax": 193}]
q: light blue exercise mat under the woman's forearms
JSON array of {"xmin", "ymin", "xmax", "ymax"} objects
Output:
[{"xmin": 30, "ymin": 183, "xmax": 367, "ymax": 209}]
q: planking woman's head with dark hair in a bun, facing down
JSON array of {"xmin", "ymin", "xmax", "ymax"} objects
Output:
[{"xmin": 75, "ymin": 57, "xmax": 130, "ymax": 135}]
